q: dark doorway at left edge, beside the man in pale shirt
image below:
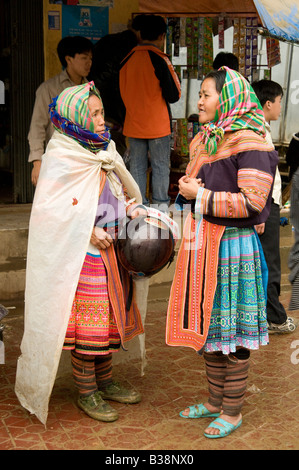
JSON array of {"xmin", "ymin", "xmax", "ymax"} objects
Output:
[{"xmin": 0, "ymin": 0, "xmax": 44, "ymax": 204}]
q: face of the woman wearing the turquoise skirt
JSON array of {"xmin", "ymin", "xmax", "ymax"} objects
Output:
[{"xmin": 197, "ymin": 78, "xmax": 219, "ymax": 124}]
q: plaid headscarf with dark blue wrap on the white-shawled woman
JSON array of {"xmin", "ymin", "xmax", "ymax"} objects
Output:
[{"xmin": 49, "ymin": 82, "xmax": 111, "ymax": 152}]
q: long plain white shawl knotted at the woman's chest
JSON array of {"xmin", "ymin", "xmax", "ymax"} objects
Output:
[{"xmin": 15, "ymin": 131, "xmax": 141, "ymax": 424}]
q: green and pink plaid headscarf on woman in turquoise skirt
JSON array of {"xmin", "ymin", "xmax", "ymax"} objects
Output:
[{"xmin": 200, "ymin": 67, "xmax": 266, "ymax": 155}]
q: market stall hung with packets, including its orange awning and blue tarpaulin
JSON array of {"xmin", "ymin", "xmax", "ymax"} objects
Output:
[{"xmin": 136, "ymin": 0, "xmax": 299, "ymax": 196}]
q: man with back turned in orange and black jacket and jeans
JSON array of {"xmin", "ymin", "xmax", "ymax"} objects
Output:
[{"xmin": 119, "ymin": 15, "xmax": 181, "ymax": 211}]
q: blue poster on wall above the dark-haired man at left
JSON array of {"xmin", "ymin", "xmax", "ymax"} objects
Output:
[{"xmin": 62, "ymin": 5, "xmax": 109, "ymax": 43}]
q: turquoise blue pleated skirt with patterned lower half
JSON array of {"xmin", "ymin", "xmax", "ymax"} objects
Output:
[{"xmin": 205, "ymin": 227, "xmax": 269, "ymax": 354}]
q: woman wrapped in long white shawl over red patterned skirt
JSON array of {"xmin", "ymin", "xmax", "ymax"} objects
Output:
[{"xmin": 16, "ymin": 82, "xmax": 144, "ymax": 424}]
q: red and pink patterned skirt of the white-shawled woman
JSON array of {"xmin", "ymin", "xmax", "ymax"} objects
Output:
[{"xmin": 63, "ymin": 253, "xmax": 121, "ymax": 355}]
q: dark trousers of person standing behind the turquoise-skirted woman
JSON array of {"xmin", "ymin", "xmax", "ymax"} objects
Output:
[{"xmin": 260, "ymin": 200, "xmax": 287, "ymax": 325}]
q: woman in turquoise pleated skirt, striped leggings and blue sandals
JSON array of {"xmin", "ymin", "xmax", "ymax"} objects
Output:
[{"xmin": 166, "ymin": 67, "xmax": 278, "ymax": 438}]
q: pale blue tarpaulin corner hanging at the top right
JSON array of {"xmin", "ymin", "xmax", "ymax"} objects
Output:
[{"xmin": 254, "ymin": 0, "xmax": 299, "ymax": 43}]
